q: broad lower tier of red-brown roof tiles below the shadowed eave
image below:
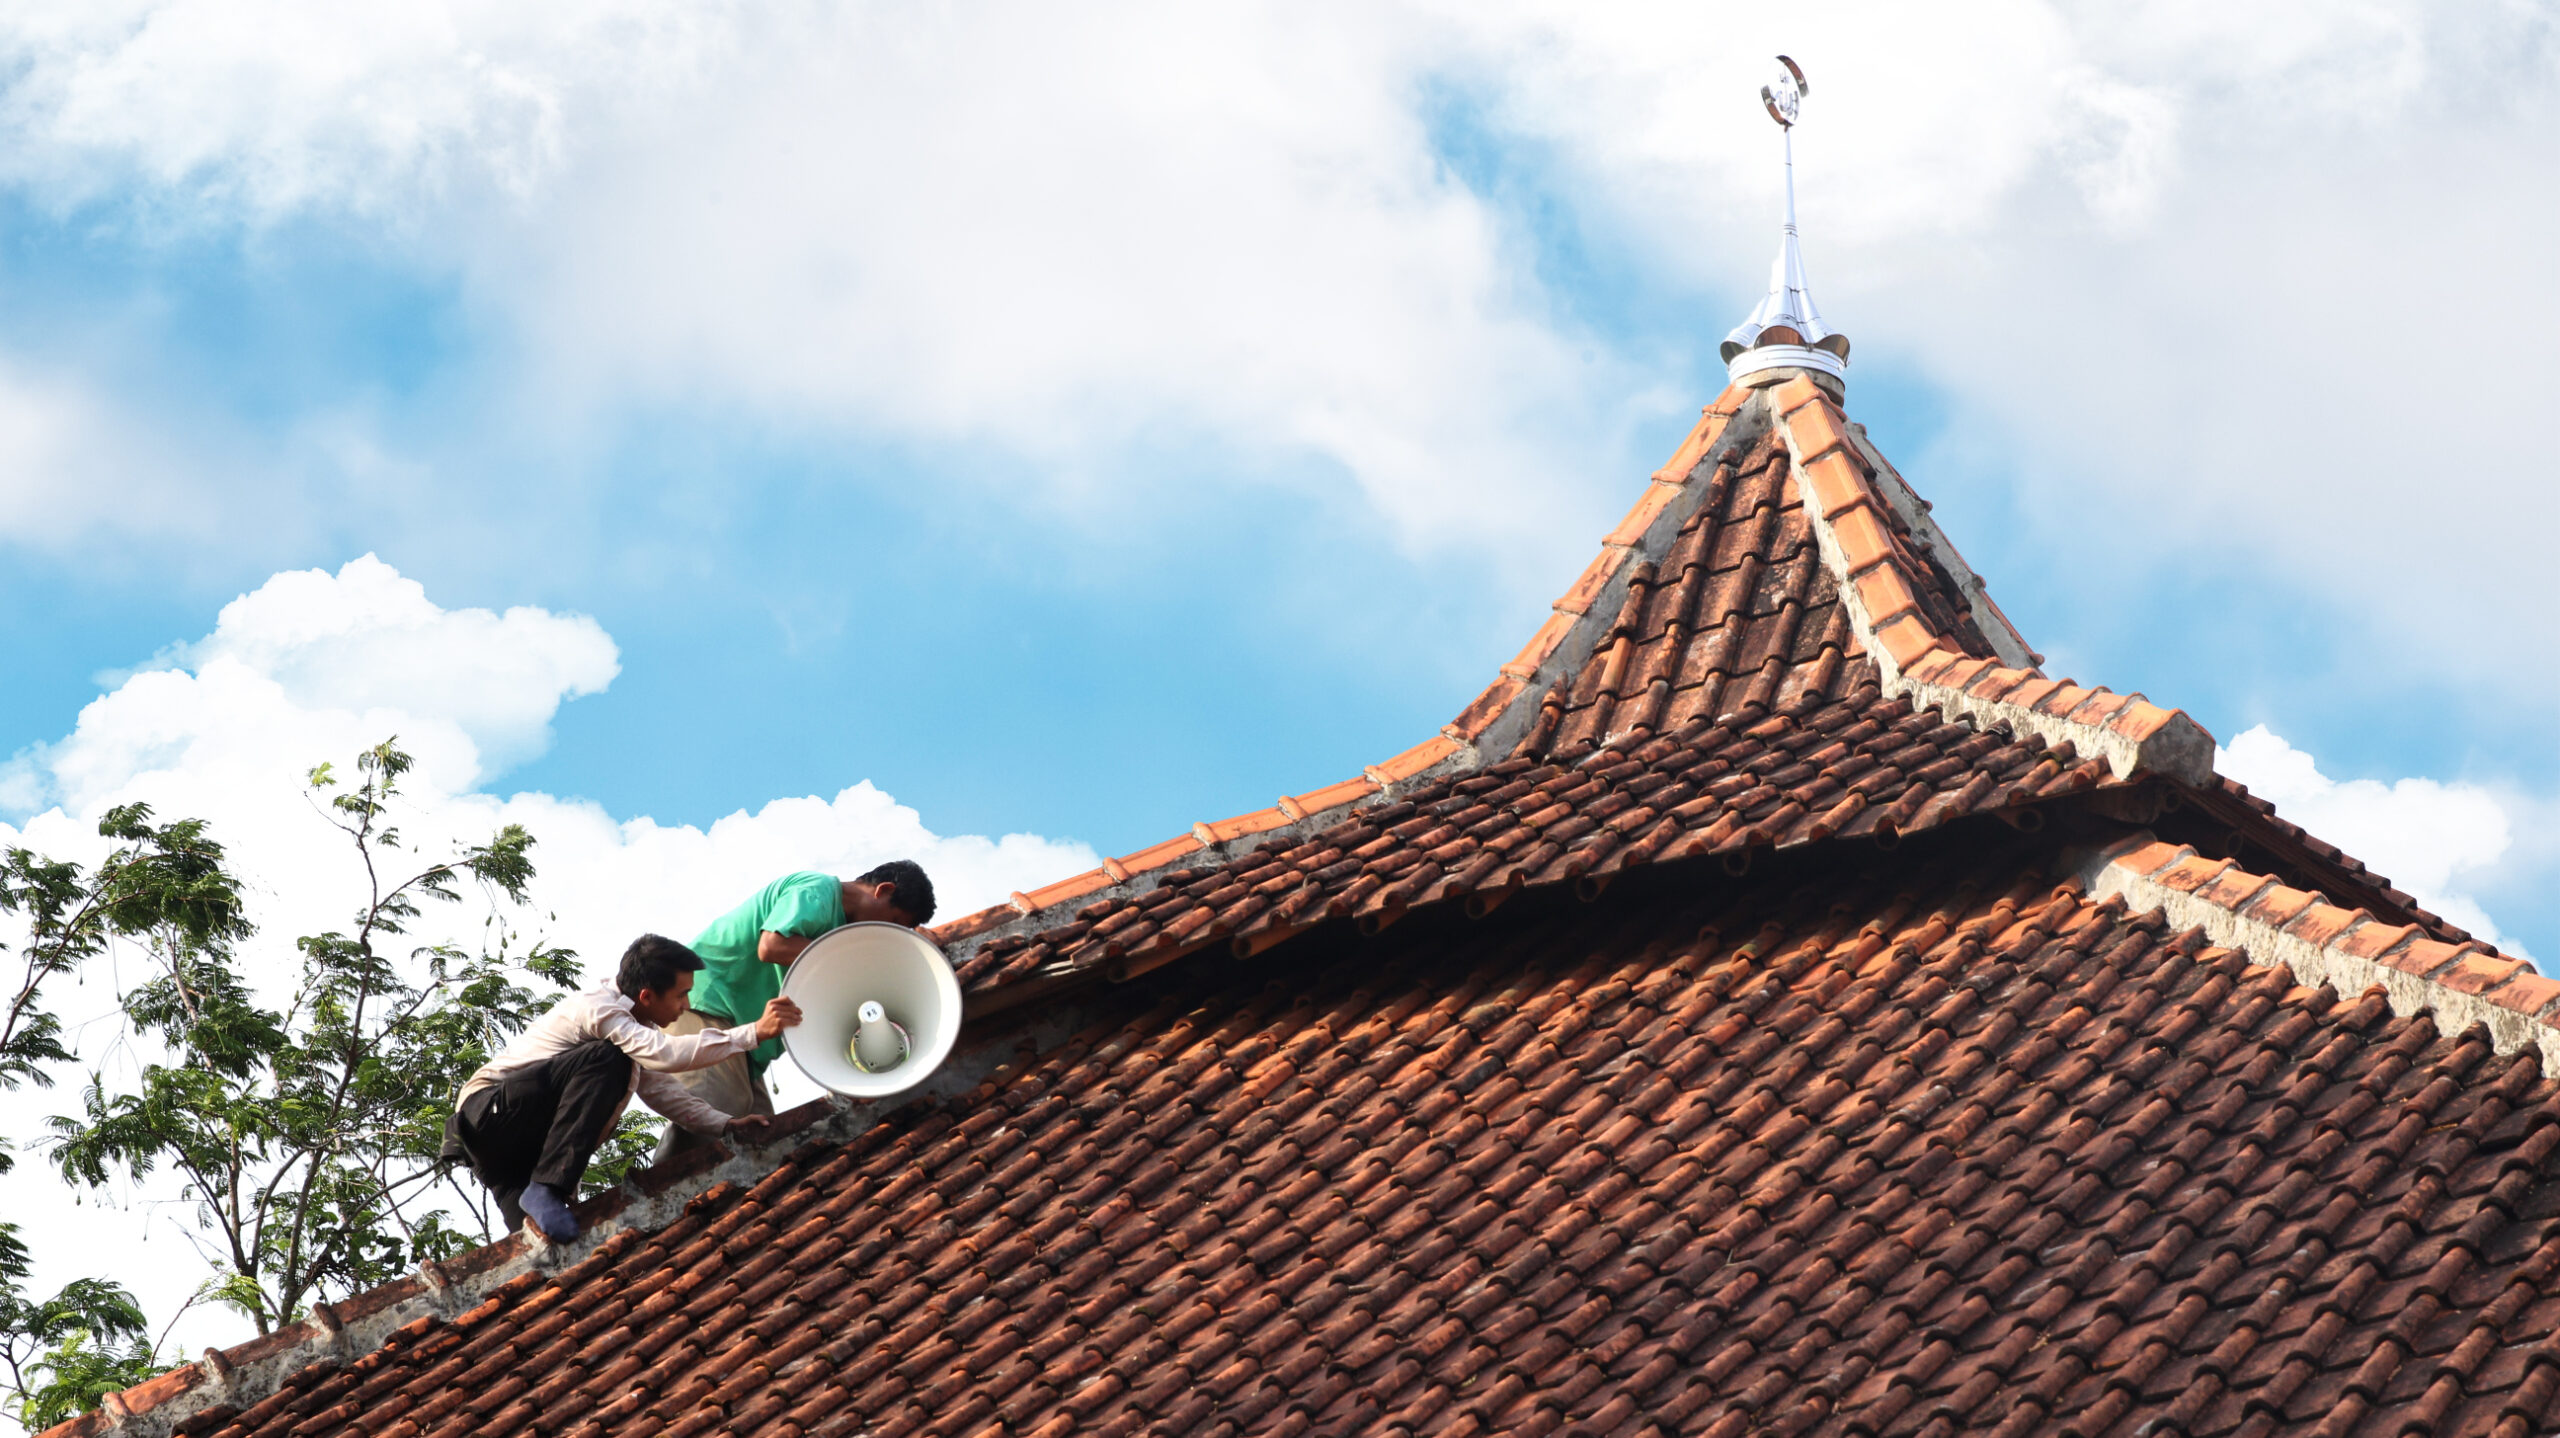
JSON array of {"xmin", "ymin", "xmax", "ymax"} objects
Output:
[{"xmin": 110, "ymin": 839, "xmax": 2560, "ymax": 1438}]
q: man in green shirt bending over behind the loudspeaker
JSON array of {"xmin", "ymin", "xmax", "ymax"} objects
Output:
[{"xmin": 658, "ymin": 860, "xmax": 934, "ymax": 1159}]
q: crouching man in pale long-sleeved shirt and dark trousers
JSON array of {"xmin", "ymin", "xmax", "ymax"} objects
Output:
[{"xmin": 443, "ymin": 934, "xmax": 799, "ymax": 1244}]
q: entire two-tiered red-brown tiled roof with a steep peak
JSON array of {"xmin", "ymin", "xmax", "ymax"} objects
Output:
[{"xmin": 55, "ymin": 363, "xmax": 2560, "ymax": 1438}]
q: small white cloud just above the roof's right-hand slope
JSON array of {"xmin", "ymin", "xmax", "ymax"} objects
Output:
[{"xmin": 2214, "ymin": 724, "xmax": 2524, "ymax": 954}]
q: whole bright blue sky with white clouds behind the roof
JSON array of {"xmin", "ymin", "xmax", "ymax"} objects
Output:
[{"xmin": 0, "ymin": 0, "xmax": 2560, "ymax": 1391}]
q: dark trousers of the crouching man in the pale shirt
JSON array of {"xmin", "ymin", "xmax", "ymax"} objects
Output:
[{"xmin": 443, "ymin": 1039, "xmax": 632, "ymax": 1228}]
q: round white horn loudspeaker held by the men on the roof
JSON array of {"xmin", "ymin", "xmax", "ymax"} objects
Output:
[{"xmin": 783, "ymin": 921, "xmax": 960, "ymax": 1098}]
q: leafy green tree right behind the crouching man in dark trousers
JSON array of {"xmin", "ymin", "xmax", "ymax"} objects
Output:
[{"xmin": 51, "ymin": 739, "xmax": 591, "ymax": 1333}]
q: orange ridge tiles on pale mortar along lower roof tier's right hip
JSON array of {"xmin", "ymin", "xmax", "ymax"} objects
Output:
[{"xmin": 2063, "ymin": 829, "xmax": 2560, "ymax": 1072}]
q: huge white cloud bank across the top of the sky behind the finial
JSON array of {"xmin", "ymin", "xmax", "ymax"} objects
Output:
[{"xmin": 0, "ymin": 0, "xmax": 2560, "ymax": 701}]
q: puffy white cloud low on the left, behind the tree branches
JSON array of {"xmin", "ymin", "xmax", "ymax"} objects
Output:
[{"xmin": 0, "ymin": 555, "xmax": 1098, "ymax": 1381}]
